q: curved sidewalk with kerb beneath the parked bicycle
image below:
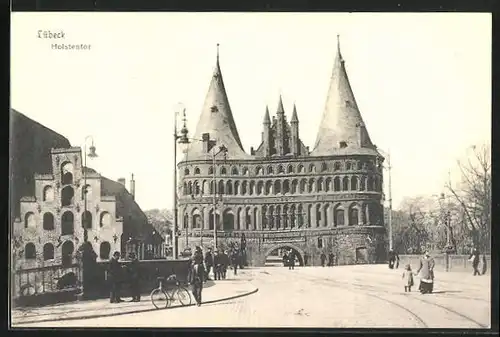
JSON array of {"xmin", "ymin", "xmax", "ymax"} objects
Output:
[{"xmin": 12, "ymin": 278, "xmax": 258, "ymax": 327}]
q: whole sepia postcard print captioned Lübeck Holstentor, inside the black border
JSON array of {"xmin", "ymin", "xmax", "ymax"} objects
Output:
[{"xmin": 9, "ymin": 12, "xmax": 492, "ymax": 329}]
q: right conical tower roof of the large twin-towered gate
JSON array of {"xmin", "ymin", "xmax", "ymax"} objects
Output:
[{"xmin": 311, "ymin": 35, "xmax": 374, "ymax": 156}]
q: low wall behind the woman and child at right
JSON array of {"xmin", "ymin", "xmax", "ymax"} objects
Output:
[{"xmin": 399, "ymin": 254, "xmax": 491, "ymax": 273}]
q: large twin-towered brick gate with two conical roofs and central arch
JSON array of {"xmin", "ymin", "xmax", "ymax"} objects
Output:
[{"xmin": 178, "ymin": 38, "xmax": 386, "ymax": 265}]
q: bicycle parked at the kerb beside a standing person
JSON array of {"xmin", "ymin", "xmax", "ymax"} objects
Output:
[{"xmin": 151, "ymin": 275, "xmax": 192, "ymax": 309}]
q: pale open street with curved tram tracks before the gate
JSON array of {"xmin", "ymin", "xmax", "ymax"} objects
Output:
[{"xmin": 15, "ymin": 265, "xmax": 490, "ymax": 329}]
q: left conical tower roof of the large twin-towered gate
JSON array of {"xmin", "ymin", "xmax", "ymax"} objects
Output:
[{"xmin": 186, "ymin": 45, "xmax": 250, "ymax": 160}]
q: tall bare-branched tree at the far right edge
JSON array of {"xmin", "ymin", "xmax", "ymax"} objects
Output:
[{"xmin": 446, "ymin": 145, "xmax": 491, "ymax": 253}]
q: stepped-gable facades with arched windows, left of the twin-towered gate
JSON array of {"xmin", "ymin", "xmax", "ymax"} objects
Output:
[{"xmin": 14, "ymin": 147, "xmax": 123, "ymax": 269}]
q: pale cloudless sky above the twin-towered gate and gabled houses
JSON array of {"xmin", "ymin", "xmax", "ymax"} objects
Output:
[{"xmin": 11, "ymin": 13, "xmax": 491, "ymax": 210}]
